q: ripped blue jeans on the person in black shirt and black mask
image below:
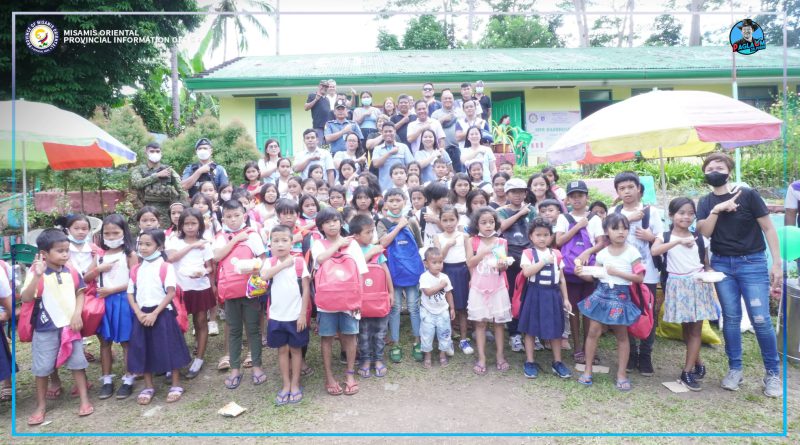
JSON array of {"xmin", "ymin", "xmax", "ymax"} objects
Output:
[{"xmin": 711, "ymin": 252, "xmax": 780, "ymax": 374}]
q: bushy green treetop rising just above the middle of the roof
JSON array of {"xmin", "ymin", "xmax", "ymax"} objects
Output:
[{"xmin": 479, "ymin": 16, "xmax": 563, "ymax": 48}]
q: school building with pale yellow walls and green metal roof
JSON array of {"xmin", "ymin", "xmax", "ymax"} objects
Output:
[{"xmin": 185, "ymin": 46, "xmax": 800, "ymax": 155}]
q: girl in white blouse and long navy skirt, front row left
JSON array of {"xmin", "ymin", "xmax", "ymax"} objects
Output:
[{"xmin": 128, "ymin": 229, "xmax": 192, "ymax": 405}]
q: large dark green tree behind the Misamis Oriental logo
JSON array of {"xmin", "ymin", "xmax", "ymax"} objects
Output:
[{"xmin": 0, "ymin": 0, "xmax": 200, "ymax": 116}]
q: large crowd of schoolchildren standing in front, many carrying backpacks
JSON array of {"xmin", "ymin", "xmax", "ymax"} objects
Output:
[{"xmin": 0, "ymin": 147, "xmax": 780, "ymax": 425}]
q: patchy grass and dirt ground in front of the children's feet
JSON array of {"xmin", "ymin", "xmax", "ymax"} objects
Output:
[{"xmin": 0, "ymin": 320, "xmax": 800, "ymax": 444}]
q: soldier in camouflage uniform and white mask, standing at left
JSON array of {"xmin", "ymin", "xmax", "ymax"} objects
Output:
[{"xmin": 131, "ymin": 142, "xmax": 189, "ymax": 228}]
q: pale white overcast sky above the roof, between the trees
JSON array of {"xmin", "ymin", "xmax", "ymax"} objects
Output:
[{"xmin": 182, "ymin": 0, "xmax": 772, "ymax": 67}]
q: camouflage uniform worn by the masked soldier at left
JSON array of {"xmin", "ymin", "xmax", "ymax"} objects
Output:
[{"xmin": 131, "ymin": 163, "xmax": 189, "ymax": 228}]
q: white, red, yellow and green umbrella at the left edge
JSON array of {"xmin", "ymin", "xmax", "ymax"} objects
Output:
[{"xmin": 0, "ymin": 100, "xmax": 136, "ymax": 236}]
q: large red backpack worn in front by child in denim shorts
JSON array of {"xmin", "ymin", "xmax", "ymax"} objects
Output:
[{"xmin": 314, "ymin": 240, "xmax": 361, "ymax": 312}]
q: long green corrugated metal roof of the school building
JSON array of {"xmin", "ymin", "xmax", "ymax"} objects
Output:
[{"xmin": 187, "ymin": 46, "xmax": 800, "ymax": 89}]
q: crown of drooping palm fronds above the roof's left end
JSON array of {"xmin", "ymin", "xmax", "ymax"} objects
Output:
[{"xmin": 206, "ymin": 0, "xmax": 275, "ymax": 62}]
